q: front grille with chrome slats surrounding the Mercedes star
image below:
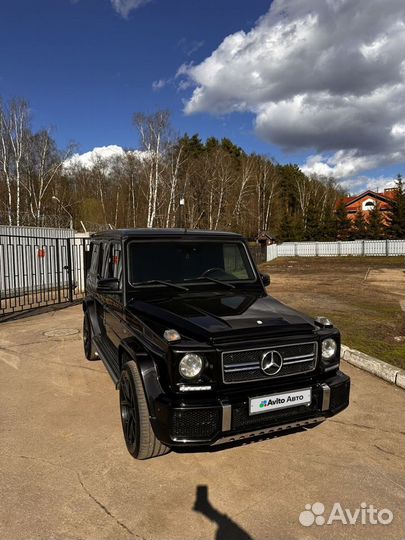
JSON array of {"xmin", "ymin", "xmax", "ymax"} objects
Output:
[{"xmin": 222, "ymin": 341, "xmax": 317, "ymax": 383}]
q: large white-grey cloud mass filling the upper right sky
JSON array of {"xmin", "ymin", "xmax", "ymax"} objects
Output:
[{"xmin": 177, "ymin": 0, "xmax": 405, "ymax": 178}]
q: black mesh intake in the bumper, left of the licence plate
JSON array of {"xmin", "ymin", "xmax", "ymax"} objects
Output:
[{"xmin": 170, "ymin": 408, "xmax": 222, "ymax": 440}]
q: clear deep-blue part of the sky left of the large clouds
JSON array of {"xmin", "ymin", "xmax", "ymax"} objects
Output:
[{"xmin": 0, "ymin": 0, "xmax": 269, "ymax": 151}]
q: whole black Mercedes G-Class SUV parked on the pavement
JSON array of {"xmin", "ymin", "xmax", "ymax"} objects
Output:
[{"xmin": 83, "ymin": 229, "xmax": 350, "ymax": 459}]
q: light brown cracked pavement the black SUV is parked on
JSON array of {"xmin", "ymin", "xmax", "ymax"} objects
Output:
[{"xmin": 0, "ymin": 306, "xmax": 405, "ymax": 540}]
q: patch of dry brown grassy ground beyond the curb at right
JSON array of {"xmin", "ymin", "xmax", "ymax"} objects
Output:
[{"xmin": 260, "ymin": 257, "xmax": 405, "ymax": 368}]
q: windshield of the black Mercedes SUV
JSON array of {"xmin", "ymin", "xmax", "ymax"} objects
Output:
[{"xmin": 129, "ymin": 241, "xmax": 255, "ymax": 284}]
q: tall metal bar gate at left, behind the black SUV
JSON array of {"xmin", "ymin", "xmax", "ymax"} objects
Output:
[{"xmin": 0, "ymin": 234, "xmax": 89, "ymax": 321}]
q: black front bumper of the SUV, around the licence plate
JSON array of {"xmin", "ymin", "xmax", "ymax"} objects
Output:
[{"xmin": 152, "ymin": 371, "xmax": 350, "ymax": 447}]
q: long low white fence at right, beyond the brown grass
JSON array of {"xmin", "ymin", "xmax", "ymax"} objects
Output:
[{"xmin": 267, "ymin": 240, "xmax": 405, "ymax": 261}]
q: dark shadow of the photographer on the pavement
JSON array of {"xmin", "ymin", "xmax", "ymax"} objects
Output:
[{"xmin": 193, "ymin": 486, "xmax": 253, "ymax": 540}]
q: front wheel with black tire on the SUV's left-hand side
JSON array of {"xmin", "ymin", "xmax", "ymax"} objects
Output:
[{"xmin": 119, "ymin": 358, "xmax": 170, "ymax": 459}]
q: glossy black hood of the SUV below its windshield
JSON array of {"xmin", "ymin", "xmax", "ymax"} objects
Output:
[{"xmin": 128, "ymin": 291, "xmax": 315, "ymax": 339}]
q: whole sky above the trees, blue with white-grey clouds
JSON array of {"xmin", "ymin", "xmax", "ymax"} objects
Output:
[{"xmin": 0, "ymin": 0, "xmax": 405, "ymax": 193}]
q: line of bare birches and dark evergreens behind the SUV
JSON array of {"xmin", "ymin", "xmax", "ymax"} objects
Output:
[{"xmin": 0, "ymin": 99, "xmax": 402, "ymax": 241}]
